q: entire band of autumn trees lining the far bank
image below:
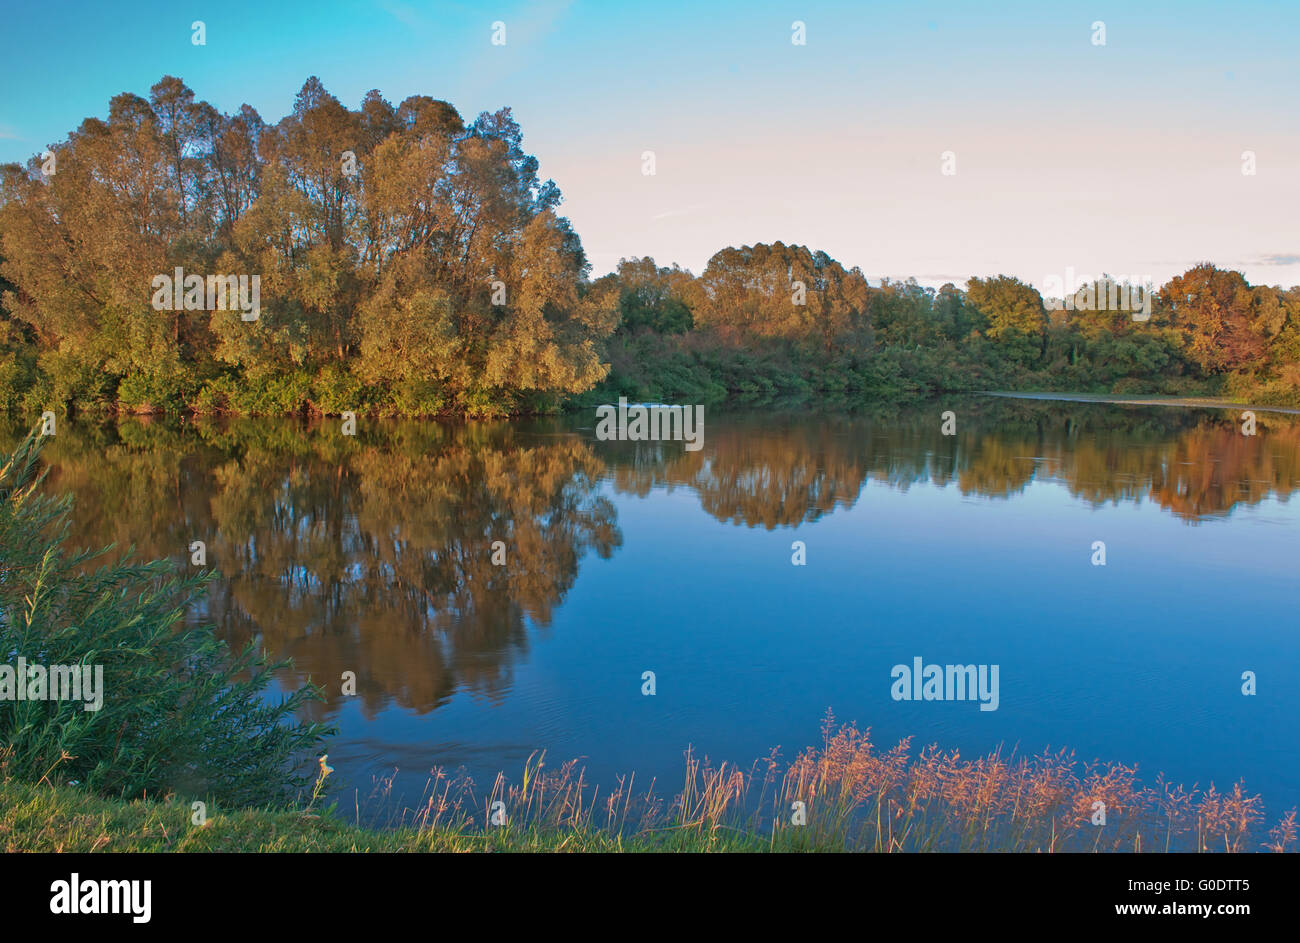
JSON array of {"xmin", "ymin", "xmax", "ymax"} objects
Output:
[{"xmin": 0, "ymin": 77, "xmax": 1300, "ymax": 416}]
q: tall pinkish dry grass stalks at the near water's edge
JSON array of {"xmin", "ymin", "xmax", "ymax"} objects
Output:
[{"xmin": 343, "ymin": 714, "xmax": 1297, "ymax": 852}]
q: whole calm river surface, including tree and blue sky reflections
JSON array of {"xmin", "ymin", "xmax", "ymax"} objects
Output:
[{"xmin": 12, "ymin": 398, "xmax": 1300, "ymax": 812}]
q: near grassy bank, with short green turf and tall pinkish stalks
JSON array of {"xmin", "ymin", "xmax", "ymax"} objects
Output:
[{"xmin": 0, "ymin": 718, "xmax": 1296, "ymax": 853}]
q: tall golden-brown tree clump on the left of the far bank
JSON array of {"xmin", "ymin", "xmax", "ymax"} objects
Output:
[{"xmin": 0, "ymin": 75, "xmax": 616, "ymax": 414}]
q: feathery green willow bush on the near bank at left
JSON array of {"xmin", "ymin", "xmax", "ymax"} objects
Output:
[{"xmin": 0, "ymin": 426, "xmax": 325, "ymax": 805}]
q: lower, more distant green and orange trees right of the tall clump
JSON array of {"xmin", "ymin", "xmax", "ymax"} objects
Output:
[{"xmin": 592, "ymin": 253, "xmax": 1300, "ymax": 405}]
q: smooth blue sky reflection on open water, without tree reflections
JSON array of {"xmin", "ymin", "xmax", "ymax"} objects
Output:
[{"xmin": 314, "ymin": 470, "xmax": 1300, "ymax": 810}]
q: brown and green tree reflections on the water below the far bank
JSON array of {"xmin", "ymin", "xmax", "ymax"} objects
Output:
[{"xmin": 12, "ymin": 399, "xmax": 1300, "ymax": 715}]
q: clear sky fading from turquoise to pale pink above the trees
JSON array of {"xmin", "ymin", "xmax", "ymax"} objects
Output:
[{"xmin": 0, "ymin": 0, "xmax": 1300, "ymax": 286}]
